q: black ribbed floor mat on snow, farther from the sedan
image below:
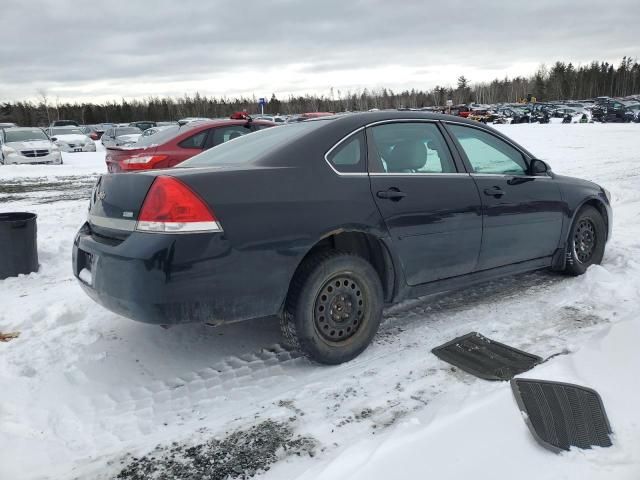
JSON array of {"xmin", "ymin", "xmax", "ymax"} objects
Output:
[{"xmin": 511, "ymin": 378, "xmax": 612, "ymax": 452}]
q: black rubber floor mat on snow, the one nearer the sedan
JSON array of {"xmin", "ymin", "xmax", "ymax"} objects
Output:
[{"xmin": 431, "ymin": 332, "xmax": 542, "ymax": 380}]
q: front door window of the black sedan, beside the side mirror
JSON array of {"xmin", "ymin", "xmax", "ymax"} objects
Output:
[{"xmin": 449, "ymin": 124, "xmax": 527, "ymax": 175}]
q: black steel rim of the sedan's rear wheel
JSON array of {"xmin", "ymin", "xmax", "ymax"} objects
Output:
[{"xmin": 313, "ymin": 274, "xmax": 367, "ymax": 343}]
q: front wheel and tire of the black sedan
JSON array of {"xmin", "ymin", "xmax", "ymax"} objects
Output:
[{"xmin": 564, "ymin": 206, "xmax": 607, "ymax": 275}]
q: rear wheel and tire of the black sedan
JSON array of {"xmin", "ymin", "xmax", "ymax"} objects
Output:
[{"xmin": 280, "ymin": 250, "xmax": 383, "ymax": 365}]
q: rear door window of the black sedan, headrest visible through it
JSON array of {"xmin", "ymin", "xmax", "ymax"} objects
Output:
[{"xmin": 369, "ymin": 122, "xmax": 456, "ymax": 174}]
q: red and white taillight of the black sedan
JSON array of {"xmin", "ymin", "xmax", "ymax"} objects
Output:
[{"xmin": 136, "ymin": 177, "xmax": 222, "ymax": 233}]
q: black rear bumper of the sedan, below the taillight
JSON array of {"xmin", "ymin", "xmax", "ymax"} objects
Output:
[{"xmin": 73, "ymin": 224, "xmax": 283, "ymax": 325}]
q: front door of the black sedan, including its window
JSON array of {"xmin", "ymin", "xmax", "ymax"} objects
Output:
[{"xmin": 446, "ymin": 123, "xmax": 564, "ymax": 270}]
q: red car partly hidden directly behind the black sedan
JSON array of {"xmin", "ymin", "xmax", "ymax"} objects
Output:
[{"xmin": 105, "ymin": 119, "xmax": 276, "ymax": 172}]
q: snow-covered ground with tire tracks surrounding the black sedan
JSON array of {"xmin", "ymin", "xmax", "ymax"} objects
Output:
[{"xmin": 0, "ymin": 124, "xmax": 640, "ymax": 480}]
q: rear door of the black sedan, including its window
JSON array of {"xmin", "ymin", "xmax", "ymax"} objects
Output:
[{"xmin": 367, "ymin": 121, "xmax": 482, "ymax": 285}]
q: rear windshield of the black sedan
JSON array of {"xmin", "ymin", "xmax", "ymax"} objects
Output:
[{"xmin": 176, "ymin": 121, "xmax": 326, "ymax": 168}]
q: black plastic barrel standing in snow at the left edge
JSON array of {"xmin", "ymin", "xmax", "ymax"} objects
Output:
[{"xmin": 0, "ymin": 212, "xmax": 38, "ymax": 280}]
